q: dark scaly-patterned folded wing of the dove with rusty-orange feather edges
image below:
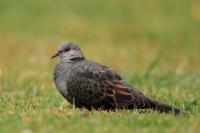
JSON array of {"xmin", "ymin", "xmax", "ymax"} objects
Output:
[{"xmin": 70, "ymin": 62, "xmax": 134, "ymax": 108}]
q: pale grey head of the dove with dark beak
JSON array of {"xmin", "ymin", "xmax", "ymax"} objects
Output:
[{"xmin": 52, "ymin": 42, "xmax": 84, "ymax": 60}]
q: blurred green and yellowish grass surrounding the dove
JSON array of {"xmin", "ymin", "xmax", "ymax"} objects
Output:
[{"xmin": 0, "ymin": 0, "xmax": 200, "ymax": 133}]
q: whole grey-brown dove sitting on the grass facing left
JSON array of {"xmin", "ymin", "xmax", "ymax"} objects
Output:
[{"xmin": 52, "ymin": 41, "xmax": 182, "ymax": 114}]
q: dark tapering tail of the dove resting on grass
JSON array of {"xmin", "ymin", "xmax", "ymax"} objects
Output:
[{"xmin": 134, "ymin": 95, "xmax": 183, "ymax": 114}]
